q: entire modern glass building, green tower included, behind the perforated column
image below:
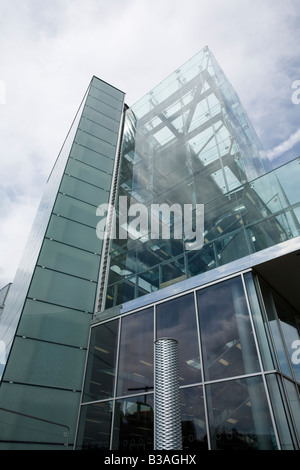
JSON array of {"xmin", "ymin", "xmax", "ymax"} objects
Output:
[{"xmin": 0, "ymin": 48, "xmax": 300, "ymax": 451}]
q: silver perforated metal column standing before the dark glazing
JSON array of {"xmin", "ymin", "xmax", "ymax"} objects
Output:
[{"xmin": 154, "ymin": 338, "xmax": 182, "ymax": 450}]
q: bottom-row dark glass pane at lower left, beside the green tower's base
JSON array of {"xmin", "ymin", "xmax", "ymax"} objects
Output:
[{"xmin": 76, "ymin": 401, "xmax": 112, "ymax": 450}]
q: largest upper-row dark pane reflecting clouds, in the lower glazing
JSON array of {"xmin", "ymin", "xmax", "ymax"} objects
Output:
[{"xmin": 197, "ymin": 277, "xmax": 259, "ymax": 380}]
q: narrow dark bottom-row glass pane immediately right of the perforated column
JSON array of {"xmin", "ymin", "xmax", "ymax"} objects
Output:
[{"xmin": 180, "ymin": 387, "xmax": 207, "ymax": 452}]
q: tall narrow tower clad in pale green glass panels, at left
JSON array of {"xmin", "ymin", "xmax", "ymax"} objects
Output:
[{"xmin": 0, "ymin": 77, "xmax": 124, "ymax": 449}]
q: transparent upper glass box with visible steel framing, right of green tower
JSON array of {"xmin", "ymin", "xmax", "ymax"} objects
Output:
[{"xmin": 103, "ymin": 48, "xmax": 300, "ymax": 310}]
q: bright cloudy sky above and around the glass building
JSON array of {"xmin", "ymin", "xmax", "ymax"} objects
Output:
[{"xmin": 0, "ymin": 0, "xmax": 300, "ymax": 288}]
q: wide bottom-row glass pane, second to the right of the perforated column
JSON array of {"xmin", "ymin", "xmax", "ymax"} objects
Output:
[{"xmin": 207, "ymin": 377, "xmax": 277, "ymax": 451}]
